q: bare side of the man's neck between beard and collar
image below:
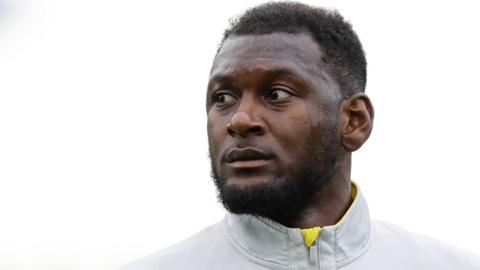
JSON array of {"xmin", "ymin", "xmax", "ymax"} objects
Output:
[{"xmin": 285, "ymin": 155, "xmax": 353, "ymax": 229}]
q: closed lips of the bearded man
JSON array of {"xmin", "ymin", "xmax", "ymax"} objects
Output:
[{"xmin": 225, "ymin": 147, "xmax": 273, "ymax": 169}]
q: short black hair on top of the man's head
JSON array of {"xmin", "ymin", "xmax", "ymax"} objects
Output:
[{"xmin": 219, "ymin": 2, "xmax": 367, "ymax": 98}]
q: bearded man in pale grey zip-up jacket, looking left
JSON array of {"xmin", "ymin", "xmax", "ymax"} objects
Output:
[{"xmin": 123, "ymin": 2, "xmax": 480, "ymax": 270}]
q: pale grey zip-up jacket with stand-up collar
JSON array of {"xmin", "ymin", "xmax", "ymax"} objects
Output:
[{"xmin": 121, "ymin": 186, "xmax": 480, "ymax": 270}]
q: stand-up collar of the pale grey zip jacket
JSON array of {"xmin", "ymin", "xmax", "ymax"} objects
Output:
[{"xmin": 223, "ymin": 184, "xmax": 371, "ymax": 266}]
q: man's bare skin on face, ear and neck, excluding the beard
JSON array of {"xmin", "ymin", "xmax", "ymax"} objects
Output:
[{"xmin": 207, "ymin": 33, "xmax": 373, "ymax": 228}]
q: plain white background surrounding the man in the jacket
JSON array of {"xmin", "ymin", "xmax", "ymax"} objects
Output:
[{"xmin": 0, "ymin": 0, "xmax": 480, "ymax": 270}]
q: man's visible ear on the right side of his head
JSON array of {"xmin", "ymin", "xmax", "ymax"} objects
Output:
[{"xmin": 339, "ymin": 93, "xmax": 374, "ymax": 152}]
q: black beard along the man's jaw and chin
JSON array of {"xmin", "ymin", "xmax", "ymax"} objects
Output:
[{"xmin": 210, "ymin": 120, "xmax": 340, "ymax": 226}]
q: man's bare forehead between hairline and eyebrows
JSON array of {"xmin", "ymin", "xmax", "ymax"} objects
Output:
[{"xmin": 211, "ymin": 33, "xmax": 326, "ymax": 82}]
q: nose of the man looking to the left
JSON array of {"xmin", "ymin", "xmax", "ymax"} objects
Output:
[{"xmin": 227, "ymin": 111, "xmax": 265, "ymax": 137}]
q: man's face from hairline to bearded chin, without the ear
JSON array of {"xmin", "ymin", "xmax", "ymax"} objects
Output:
[{"xmin": 207, "ymin": 33, "xmax": 341, "ymax": 222}]
